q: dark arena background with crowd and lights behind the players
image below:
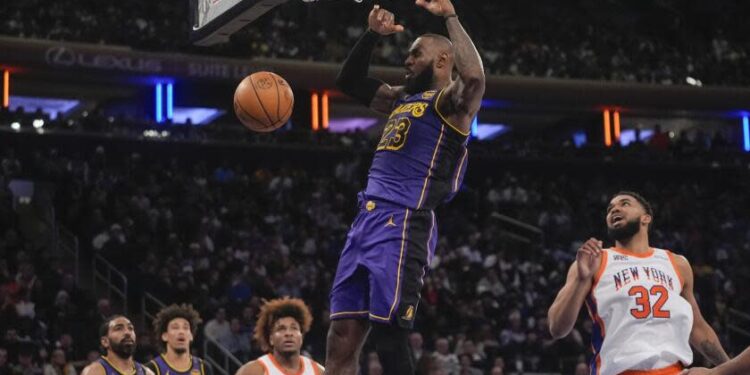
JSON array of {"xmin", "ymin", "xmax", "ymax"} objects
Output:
[{"xmin": 0, "ymin": 0, "xmax": 750, "ymax": 375}]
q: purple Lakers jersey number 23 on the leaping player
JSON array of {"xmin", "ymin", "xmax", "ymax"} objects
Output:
[{"xmin": 365, "ymin": 90, "xmax": 468, "ymax": 209}]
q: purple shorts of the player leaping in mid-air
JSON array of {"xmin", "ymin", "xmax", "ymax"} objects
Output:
[{"xmin": 331, "ymin": 193, "xmax": 437, "ymax": 328}]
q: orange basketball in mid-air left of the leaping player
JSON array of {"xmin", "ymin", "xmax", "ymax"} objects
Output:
[{"xmin": 234, "ymin": 72, "xmax": 294, "ymax": 133}]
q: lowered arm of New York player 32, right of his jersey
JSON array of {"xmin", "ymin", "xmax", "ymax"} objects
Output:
[{"xmin": 674, "ymin": 255, "xmax": 729, "ymax": 365}]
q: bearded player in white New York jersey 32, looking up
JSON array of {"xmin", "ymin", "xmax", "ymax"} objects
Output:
[{"xmin": 548, "ymin": 192, "xmax": 729, "ymax": 375}]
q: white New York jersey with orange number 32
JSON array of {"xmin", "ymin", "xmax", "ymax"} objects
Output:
[{"xmin": 586, "ymin": 248, "xmax": 693, "ymax": 375}]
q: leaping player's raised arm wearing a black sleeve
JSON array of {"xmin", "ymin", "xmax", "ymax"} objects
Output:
[{"xmin": 336, "ymin": 5, "xmax": 404, "ymax": 113}]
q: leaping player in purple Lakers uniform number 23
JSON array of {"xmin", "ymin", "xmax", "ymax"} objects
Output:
[{"xmin": 326, "ymin": 0, "xmax": 485, "ymax": 375}]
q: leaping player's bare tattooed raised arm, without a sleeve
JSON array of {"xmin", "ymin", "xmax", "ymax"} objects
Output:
[{"xmin": 416, "ymin": 0, "xmax": 485, "ymax": 134}]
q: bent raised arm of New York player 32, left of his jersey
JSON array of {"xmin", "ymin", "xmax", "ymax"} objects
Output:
[{"xmin": 547, "ymin": 238, "xmax": 603, "ymax": 339}]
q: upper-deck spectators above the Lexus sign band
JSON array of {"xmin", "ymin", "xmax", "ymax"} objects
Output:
[{"xmin": 0, "ymin": 0, "xmax": 750, "ymax": 86}]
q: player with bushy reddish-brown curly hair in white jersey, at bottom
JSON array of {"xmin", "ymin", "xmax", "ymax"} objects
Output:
[{"xmin": 235, "ymin": 298, "xmax": 325, "ymax": 375}]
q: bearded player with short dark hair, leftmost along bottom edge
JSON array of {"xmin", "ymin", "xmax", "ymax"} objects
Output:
[{"xmin": 81, "ymin": 315, "xmax": 154, "ymax": 375}]
